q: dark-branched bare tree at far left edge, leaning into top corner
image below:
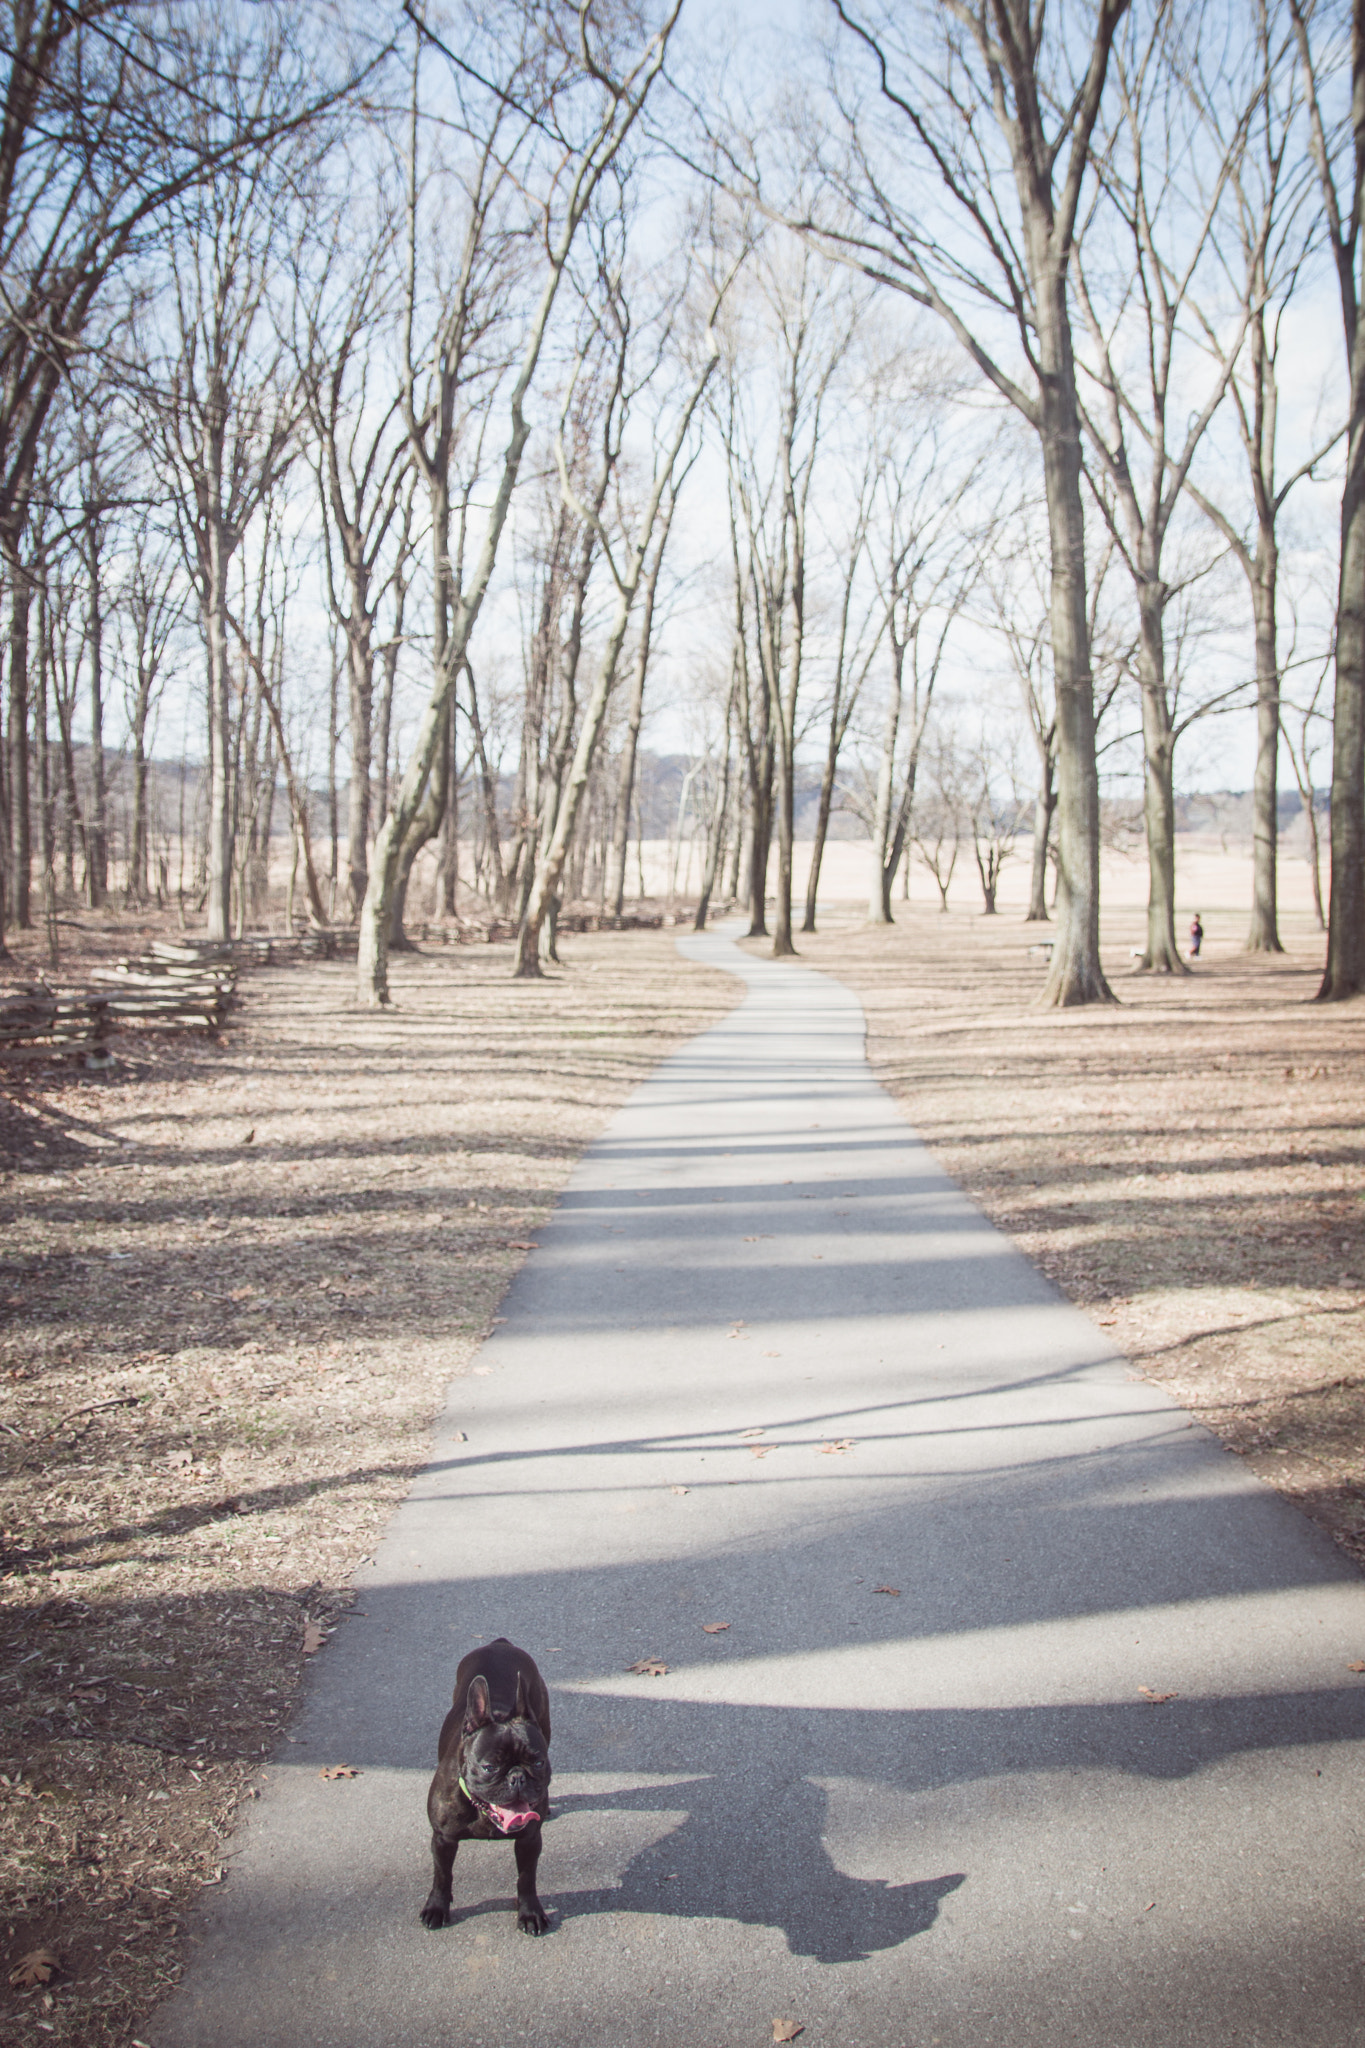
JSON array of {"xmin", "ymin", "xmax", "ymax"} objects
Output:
[{"xmin": 0, "ymin": 0, "xmax": 372, "ymax": 928}]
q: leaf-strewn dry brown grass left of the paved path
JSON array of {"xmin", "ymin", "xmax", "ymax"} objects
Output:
[{"xmin": 0, "ymin": 926, "xmax": 739, "ymax": 2048}]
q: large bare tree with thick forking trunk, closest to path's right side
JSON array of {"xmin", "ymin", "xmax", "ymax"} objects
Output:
[{"xmin": 784, "ymin": 0, "xmax": 1128, "ymax": 1004}]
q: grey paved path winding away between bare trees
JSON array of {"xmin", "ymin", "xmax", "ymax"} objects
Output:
[{"xmin": 145, "ymin": 936, "xmax": 1365, "ymax": 2048}]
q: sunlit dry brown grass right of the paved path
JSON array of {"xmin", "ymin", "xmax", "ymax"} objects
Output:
[{"xmin": 800, "ymin": 903, "xmax": 1365, "ymax": 1563}]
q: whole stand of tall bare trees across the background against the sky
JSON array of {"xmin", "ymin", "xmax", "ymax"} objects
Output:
[{"xmin": 0, "ymin": 0, "xmax": 1365, "ymax": 1004}]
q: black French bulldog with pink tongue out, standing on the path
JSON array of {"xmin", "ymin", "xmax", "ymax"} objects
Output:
[{"xmin": 422, "ymin": 1636, "xmax": 551, "ymax": 1933}]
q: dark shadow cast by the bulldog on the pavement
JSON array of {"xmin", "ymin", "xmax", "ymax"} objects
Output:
[{"xmin": 452, "ymin": 1778, "xmax": 966, "ymax": 1962}]
